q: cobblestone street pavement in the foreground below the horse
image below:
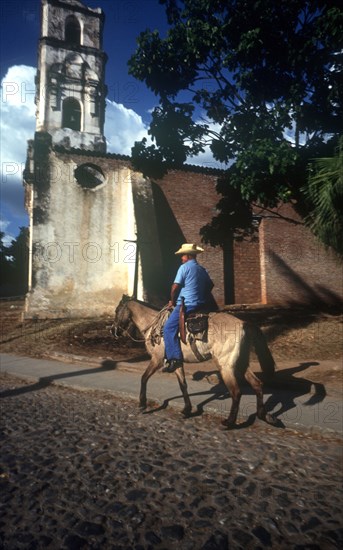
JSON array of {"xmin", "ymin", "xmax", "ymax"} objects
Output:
[{"xmin": 0, "ymin": 374, "xmax": 343, "ymax": 550}]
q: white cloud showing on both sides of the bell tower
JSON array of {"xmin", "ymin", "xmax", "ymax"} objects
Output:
[{"xmin": 0, "ymin": 65, "xmax": 147, "ymax": 239}]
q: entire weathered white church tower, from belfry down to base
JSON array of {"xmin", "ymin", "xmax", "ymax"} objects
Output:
[{"xmin": 24, "ymin": 0, "xmax": 157, "ymax": 319}]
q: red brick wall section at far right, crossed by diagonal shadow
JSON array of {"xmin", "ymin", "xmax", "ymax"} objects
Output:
[{"xmin": 260, "ymin": 204, "xmax": 343, "ymax": 305}]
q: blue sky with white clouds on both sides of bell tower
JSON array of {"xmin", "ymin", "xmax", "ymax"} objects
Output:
[{"xmin": 0, "ymin": 0, "xmax": 179, "ymax": 240}]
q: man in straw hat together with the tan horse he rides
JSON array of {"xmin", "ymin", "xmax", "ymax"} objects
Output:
[{"xmin": 113, "ymin": 249, "xmax": 276, "ymax": 429}]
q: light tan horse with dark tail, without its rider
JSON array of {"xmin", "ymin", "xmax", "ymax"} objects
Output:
[{"xmin": 111, "ymin": 295, "xmax": 276, "ymax": 429}]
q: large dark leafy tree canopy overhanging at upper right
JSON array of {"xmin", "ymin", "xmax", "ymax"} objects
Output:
[{"xmin": 129, "ymin": 0, "xmax": 343, "ymax": 244}]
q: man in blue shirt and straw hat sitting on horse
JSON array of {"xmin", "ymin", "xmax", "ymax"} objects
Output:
[{"xmin": 162, "ymin": 243, "xmax": 214, "ymax": 372}]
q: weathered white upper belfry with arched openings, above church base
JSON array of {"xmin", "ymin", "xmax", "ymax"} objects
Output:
[{"xmin": 36, "ymin": 0, "xmax": 107, "ymax": 152}]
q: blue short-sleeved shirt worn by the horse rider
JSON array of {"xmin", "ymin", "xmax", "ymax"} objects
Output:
[{"xmin": 174, "ymin": 260, "xmax": 212, "ymax": 307}]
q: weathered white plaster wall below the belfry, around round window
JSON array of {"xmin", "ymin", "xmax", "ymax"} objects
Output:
[{"xmin": 26, "ymin": 152, "xmax": 146, "ymax": 317}]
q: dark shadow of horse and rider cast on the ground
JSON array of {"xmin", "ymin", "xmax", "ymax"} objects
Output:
[{"xmin": 144, "ymin": 361, "xmax": 326, "ymax": 429}]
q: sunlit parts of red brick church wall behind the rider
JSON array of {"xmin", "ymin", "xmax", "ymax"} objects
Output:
[{"xmin": 159, "ymin": 170, "xmax": 343, "ymax": 306}]
